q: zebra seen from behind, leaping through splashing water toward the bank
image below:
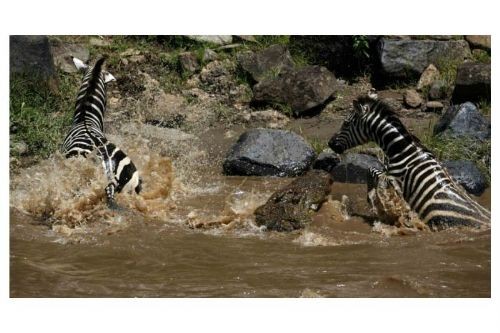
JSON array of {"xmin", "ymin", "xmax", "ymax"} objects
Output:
[{"xmin": 62, "ymin": 58, "xmax": 142, "ymax": 208}]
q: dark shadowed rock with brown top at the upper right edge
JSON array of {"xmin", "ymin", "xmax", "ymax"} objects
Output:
[{"xmin": 451, "ymin": 62, "xmax": 491, "ymax": 104}]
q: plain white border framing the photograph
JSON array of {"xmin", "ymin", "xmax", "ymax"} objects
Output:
[{"xmin": 0, "ymin": 0, "xmax": 500, "ymax": 332}]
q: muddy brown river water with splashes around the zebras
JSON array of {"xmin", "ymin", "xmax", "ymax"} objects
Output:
[{"xmin": 10, "ymin": 123, "xmax": 491, "ymax": 297}]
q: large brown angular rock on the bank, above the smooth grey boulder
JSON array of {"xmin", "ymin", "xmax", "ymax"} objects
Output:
[{"xmin": 253, "ymin": 66, "xmax": 336, "ymax": 115}]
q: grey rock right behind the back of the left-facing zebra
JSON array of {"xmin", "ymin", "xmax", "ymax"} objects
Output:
[{"xmin": 443, "ymin": 160, "xmax": 487, "ymax": 195}]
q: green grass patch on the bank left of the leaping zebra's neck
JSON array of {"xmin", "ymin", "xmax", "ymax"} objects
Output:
[{"xmin": 9, "ymin": 74, "xmax": 78, "ymax": 159}]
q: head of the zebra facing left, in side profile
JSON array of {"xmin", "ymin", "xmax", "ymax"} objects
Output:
[{"xmin": 328, "ymin": 94, "xmax": 377, "ymax": 154}]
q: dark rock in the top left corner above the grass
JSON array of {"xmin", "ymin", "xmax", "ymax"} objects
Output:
[{"xmin": 9, "ymin": 35, "xmax": 56, "ymax": 79}]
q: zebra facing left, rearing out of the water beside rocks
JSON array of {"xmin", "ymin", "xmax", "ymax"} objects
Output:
[{"xmin": 328, "ymin": 94, "xmax": 491, "ymax": 230}]
